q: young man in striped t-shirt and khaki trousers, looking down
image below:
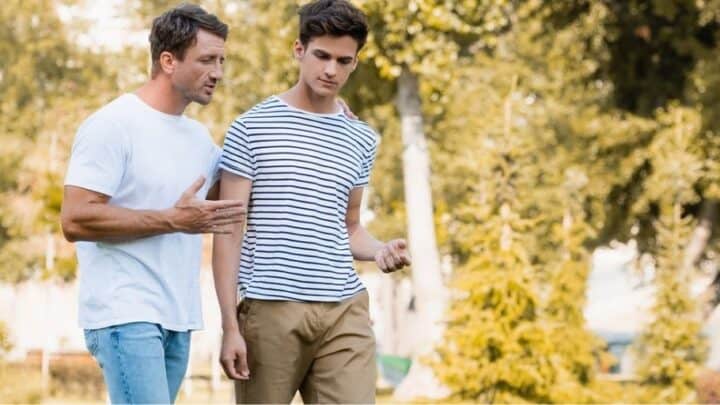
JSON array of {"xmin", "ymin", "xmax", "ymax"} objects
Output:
[{"xmin": 213, "ymin": 0, "xmax": 410, "ymax": 403}]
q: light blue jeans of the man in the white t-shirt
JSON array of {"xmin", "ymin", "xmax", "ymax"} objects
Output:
[{"xmin": 85, "ymin": 322, "xmax": 190, "ymax": 404}]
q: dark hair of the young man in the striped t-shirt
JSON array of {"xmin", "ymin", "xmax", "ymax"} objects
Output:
[{"xmin": 298, "ymin": 0, "xmax": 368, "ymax": 51}]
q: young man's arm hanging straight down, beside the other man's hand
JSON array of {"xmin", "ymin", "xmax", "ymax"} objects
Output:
[{"xmin": 212, "ymin": 171, "xmax": 252, "ymax": 380}]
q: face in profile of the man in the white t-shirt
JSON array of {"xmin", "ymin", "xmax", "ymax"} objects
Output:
[{"xmin": 171, "ymin": 29, "xmax": 225, "ymax": 105}]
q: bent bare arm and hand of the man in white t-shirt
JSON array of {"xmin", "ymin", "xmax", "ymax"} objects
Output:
[{"xmin": 60, "ymin": 177, "xmax": 245, "ymax": 242}]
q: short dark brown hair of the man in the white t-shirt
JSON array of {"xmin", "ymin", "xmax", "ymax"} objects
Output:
[{"xmin": 148, "ymin": 4, "xmax": 228, "ymax": 76}]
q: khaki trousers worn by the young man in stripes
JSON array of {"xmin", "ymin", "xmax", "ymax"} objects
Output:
[{"xmin": 235, "ymin": 291, "xmax": 376, "ymax": 404}]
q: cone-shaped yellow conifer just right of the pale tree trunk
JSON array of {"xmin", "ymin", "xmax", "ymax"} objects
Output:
[{"xmin": 436, "ymin": 76, "xmax": 563, "ymax": 403}]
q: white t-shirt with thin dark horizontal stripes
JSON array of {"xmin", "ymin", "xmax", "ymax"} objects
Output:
[{"xmin": 220, "ymin": 96, "xmax": 377, "ymax": 302}]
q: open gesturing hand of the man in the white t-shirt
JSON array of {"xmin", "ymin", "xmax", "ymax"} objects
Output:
[{"xmin": 169, "ymin": 176, "xmax": 246, "ymax": 233}]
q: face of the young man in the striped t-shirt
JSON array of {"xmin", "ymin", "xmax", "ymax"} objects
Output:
[{"xmin": 294, "ymin": 35, "xmax": 358, "ymax": 97}]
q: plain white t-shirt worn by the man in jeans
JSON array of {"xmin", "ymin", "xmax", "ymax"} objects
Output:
[{"xmin": 65, "ymin": 94, "xmax": 220, "ymax": 331}]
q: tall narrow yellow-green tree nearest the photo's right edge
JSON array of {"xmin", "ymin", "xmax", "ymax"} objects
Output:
[{"xmin": 635, "ymin": 107, "xmax": 707, "ymax": 402}]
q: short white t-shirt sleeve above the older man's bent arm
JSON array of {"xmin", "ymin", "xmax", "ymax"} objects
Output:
[{"xmin": 65, "ymin": 118, "xmax": 127, "ymax": 197}]
